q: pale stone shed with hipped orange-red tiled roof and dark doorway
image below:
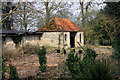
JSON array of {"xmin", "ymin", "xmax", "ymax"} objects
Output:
[{"xmin": 37, "ymin": 17, "xmax": 84, "ymax": 48}]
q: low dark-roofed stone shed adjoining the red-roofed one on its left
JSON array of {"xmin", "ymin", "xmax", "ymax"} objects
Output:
[{"xmin": 0, "ymin": 30, "xmax": 42, "ymax": 50}]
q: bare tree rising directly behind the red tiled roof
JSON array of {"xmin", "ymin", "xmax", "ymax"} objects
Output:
[{"xmin": 37, "ymin": 2, "xmax": 72, "ymax": 27}]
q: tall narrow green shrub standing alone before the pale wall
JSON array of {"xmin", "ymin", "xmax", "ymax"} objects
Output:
[{"xmin": 37, "ymin": 47, "xmax": 47, "ymax": 72}]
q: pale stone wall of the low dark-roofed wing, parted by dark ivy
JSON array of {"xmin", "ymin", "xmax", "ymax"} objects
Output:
[{"xmin": 3, "ymin": 35, "xmax": 41, "ymax": 50}]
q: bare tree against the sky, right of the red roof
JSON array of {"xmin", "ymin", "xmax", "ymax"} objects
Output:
[{"xmin": 77, "ymin": 0, "xmax": 104, "ymax": 27}]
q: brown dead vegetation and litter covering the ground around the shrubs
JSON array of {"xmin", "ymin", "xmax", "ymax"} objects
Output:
[{"xmin": 3, "ymin": 46, "xmax": 117, "ymax": 78}]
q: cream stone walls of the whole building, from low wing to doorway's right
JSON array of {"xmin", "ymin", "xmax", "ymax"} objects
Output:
[{"xmin": 4, "ymin": 32, "xmax": 84, "ymax": 49}]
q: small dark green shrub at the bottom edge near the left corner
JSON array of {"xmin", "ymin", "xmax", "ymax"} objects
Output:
[{"xmin": 9, "ymin": 64, "xmax": 19, "ymax": 80}]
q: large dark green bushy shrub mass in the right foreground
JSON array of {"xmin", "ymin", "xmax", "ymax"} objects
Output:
[{"xmin": 66, "ymin": 49, "xmax": 113, "ymax": 80}]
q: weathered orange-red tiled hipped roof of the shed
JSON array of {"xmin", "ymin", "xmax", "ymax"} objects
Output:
[{"xmin": 37, "ymin": 17, "xmax": 83, "ymax": 32}]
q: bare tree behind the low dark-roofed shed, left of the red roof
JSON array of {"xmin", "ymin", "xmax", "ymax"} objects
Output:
[{"xmin": 13, "ymin": 2, "xmax": 37, "ymax": 31}]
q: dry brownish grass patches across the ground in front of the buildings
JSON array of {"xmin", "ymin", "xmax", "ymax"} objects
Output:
[{"xmin": 3, "ymin": 46, "xmax": 117, "ymax": 78}]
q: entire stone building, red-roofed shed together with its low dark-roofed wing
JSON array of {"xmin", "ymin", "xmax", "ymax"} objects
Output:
[{"xmin": 0, "ymin": 17, "xmax": 84, "ymax": 49}]
